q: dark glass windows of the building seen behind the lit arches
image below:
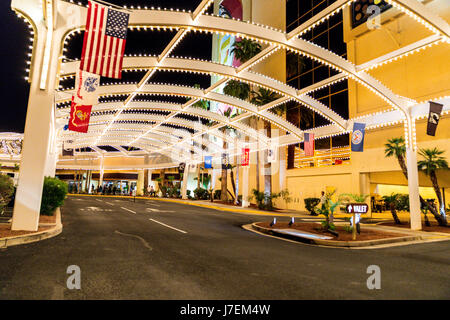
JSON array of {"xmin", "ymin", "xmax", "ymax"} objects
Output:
[{"xmin": 286, "ymin": 0, "xmax": 352, "ymax": 169}]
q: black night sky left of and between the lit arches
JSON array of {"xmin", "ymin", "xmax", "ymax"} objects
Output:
[{"xmin": 0, "ymin": 0, "xmax": 207, "ymax": 132}]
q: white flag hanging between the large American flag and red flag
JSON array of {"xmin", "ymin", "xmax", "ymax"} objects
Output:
[{"xmin": 74, "ymin": 70, "xmax": 100, "ymax": 106}]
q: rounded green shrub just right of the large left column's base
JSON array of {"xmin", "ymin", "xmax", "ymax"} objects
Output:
[{"xmin": 41, "ymin": 177, "xmax": 68, "ymax": 216}]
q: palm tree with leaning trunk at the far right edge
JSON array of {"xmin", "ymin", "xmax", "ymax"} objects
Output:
[{"xmin": 417, "ymin": 148, "xmax": 448, "ymax": 224}]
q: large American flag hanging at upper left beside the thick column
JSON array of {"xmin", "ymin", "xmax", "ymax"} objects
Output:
[{"xmin": 80, "ymin": 1, "xmax": 130, "ymax": 79}]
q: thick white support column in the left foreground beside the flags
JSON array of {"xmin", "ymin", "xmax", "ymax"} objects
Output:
[{"xmin": 11, "ymin": 10, "xmax": 60, "ymax": 231}]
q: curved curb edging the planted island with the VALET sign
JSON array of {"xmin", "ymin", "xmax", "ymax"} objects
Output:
[{"xmin": 252, "ymin": 222, "xmax": 422, "ymax": 248}]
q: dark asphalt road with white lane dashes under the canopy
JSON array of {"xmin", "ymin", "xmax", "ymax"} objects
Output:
[{"xmin": 0, "ymin": 197, "xmax": 450, "ymax": 300}]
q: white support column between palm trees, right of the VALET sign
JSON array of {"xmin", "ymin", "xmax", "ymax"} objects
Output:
[{"xmin": 406, "ymin": 148, "xmax": 422, "ymax": 230}]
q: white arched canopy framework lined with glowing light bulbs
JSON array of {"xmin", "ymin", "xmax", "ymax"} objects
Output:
[{"xmin": 13, "ymin": 0, "xmax": 450, "ymax": 162}]
